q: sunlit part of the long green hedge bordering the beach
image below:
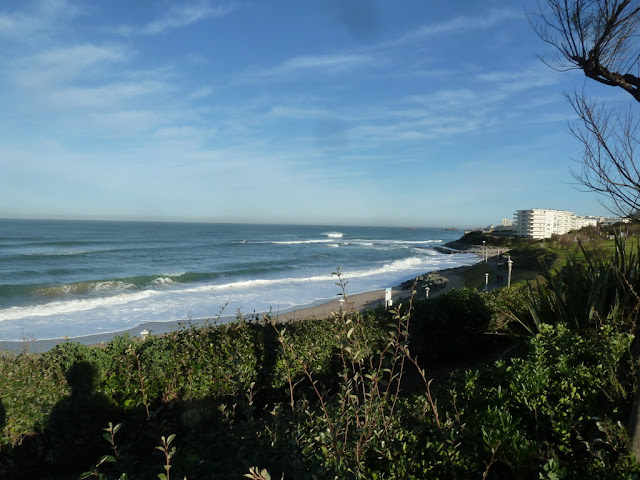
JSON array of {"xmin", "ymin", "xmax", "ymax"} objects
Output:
[{"xmin": 0, "ymin": 315, "xmax": 386, "ymax": 478}]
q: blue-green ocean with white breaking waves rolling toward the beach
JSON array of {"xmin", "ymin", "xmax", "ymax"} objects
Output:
[{"xmin": 0, "ymin": 220, "xmax": 478, "ymax": 341}]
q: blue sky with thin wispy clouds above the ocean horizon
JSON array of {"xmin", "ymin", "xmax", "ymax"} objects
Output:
[{"xmin": 0, "ymin": 0, "xmax": 626, "ymax": 227}]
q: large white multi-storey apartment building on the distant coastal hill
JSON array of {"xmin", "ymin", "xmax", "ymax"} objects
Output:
[{"xmin": 514, "ymin": 208, "xmax": 598, "ymax": 239}]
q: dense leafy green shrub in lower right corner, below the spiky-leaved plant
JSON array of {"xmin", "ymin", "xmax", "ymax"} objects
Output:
[{"xmin": 436, "ymin": 325, "xmax": 635, "ymax": 478}]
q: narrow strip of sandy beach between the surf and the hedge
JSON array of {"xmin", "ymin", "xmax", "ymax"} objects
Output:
[{"xmin": 0, "ymin": 267, "xmax": 468, "ymax": 353}]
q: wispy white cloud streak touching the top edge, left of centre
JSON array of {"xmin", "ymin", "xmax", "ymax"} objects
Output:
[{"xmin": 116, "ymin": 1, "xmax": 236, "ymax": 36}]
